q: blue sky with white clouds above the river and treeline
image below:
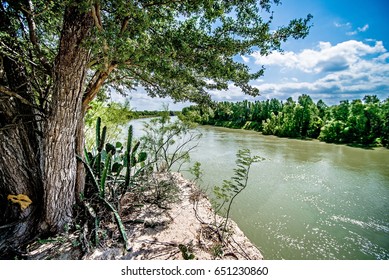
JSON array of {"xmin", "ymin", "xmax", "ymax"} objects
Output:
[{"xmin": 115, "ymin": 0, "xmax": 389, "ymax": 110}]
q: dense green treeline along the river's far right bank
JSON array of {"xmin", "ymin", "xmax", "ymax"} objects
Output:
[{"xmin": 182, "ymin": 94, "xmax": 389, "ymax": 148}]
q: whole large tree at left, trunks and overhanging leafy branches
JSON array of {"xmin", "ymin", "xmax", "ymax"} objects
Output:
[{"xmin": 0, "ymin": 0, "xmax": 311, "ymax": 254}]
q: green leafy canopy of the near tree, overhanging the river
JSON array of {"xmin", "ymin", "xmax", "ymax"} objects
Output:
[{"xmin": 0, "ymin": 0, "xmax": 312, "ymax": 108}]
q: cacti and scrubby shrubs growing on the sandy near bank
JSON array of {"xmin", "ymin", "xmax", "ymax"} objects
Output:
[{"xmin": 19, "ymin": 109, "xmax": 262, "ymax": 260}]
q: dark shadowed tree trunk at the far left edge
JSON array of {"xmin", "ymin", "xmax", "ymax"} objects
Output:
[{"xmin": 0, "ymin": 66, "xmax": 43, "ymax": 256}]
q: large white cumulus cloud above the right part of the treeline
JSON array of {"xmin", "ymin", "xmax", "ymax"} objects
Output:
[{"xmin": 249, "ymin": 40, "xmax": 389, "ymax": 103}]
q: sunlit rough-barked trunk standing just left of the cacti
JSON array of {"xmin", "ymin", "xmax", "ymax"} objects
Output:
[{"xmin": 42, "ymin": 7, "xmax": 93, "ymax": 232}]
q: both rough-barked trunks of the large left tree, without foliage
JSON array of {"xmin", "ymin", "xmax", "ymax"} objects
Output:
[{"xmin": 0, "ymin": 3, "xmax": 93, "ymax": 258}]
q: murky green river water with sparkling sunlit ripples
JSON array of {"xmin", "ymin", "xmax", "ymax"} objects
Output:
[{"xmin": 127, "ymin": 118, "xmax": 389, "ymax": 260}]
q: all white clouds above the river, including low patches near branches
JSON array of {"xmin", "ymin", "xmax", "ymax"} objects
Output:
[{"xmin": 116, "ymin": 40, "xmax": 389, "ymax": 107}]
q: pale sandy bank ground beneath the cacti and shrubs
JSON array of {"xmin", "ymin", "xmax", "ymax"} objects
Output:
[{"xmin": 27, "ymin": 173, "xmax": 263, "ymax": 260}]
